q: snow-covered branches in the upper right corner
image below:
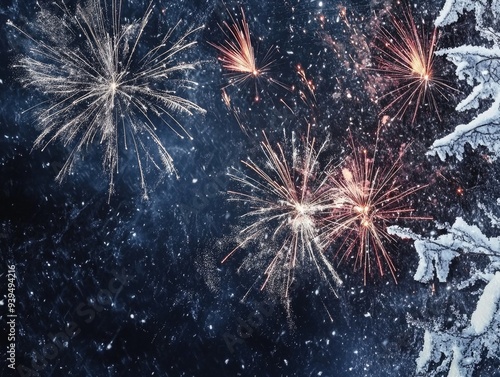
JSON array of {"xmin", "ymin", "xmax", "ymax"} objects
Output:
[{"xmin": 428, "ymin": 0, "xmax": 500, "ymax": 160}]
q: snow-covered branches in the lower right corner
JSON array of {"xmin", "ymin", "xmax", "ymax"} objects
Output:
[{"xmin": 388, "ymin": 218, "xmax": 500, "ymax": 377}]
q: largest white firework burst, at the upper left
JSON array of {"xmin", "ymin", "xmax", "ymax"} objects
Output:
[{"xmin": 9, "ymin": 0, "xmax": 204, "ymax": 196}]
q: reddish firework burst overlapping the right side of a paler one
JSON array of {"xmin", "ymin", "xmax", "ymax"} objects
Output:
[{"xmin": 323, "ymin": 140, "xmax": 428, "ymax": 284}]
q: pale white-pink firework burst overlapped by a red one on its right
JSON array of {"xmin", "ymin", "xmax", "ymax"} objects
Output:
[{"xmin": 223, "ymin": 129, "xmax": 341, "ymax": 305}]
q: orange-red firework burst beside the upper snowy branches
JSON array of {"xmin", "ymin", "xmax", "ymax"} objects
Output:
[{"xmin": 377, "ymin": 4, "xmax": 456, "ymax": 123}]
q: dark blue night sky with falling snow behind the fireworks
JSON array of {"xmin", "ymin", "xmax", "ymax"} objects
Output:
[{"xmin": 0, "ymin": 0, "xmax": 500, "ymax": 377}]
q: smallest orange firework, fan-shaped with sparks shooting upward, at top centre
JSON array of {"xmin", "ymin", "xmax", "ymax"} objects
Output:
[{"xmin": 209, "ymin": 9, "xmax": 273, "ymax": 101}]
